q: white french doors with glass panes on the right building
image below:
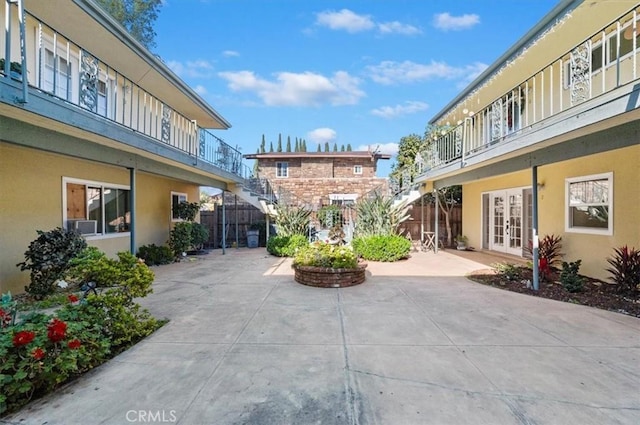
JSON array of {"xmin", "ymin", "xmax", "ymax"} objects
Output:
[{"xmin": 485, "ymin": 189, "xmax": 530, "ymax": 256}]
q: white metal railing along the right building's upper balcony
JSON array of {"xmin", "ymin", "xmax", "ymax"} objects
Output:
[{"xmin": 416, "ymin": 9, "xmax": 640, "ymax": 182}]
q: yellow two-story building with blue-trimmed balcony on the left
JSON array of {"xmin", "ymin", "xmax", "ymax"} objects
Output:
[{"xmin": 0, "ymin": 0, "xmax": 251, "ymax": 293}]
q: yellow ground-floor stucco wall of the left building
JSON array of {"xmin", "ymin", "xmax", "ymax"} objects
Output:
[{"xmin": 0, "ymin": 142, "xmax": 199, "ymax": 293}]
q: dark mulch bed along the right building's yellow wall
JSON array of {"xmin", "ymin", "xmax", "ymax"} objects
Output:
[{"xmin": 467, "ymin": 267, "xmax": 640, "ymax": 317}]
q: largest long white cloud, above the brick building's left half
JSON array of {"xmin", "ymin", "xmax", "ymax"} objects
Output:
[{"xmin": 218, "ymin": 71, "xmax": 365, "ymax": 106}]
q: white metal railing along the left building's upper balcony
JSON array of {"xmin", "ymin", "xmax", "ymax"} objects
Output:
[{"xmin": 0, "ymin": 0, "xmax": 249, "ymax": 177}]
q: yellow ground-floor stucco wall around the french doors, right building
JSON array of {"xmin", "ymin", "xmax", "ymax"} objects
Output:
[{"xmin": 463, "ymin": 146, "xmax": 640, "ymax": 279}]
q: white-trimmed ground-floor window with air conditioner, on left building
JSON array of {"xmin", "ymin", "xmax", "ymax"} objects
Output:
[{"xmin": 63, "ymin": 178, "xmax": 131, "ymax": 235}]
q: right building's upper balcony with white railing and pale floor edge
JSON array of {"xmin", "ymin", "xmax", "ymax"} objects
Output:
[{"xmin": 412, "ymin": 4, "xmax": 640, "ymax": 188}]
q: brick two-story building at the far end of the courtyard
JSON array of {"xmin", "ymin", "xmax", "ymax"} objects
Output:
[{"xmin": 244, "ymin": 151, "xmax": 391, "ymax": 209}]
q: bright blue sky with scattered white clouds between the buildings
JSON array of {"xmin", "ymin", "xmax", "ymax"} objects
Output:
[{"xmin": 154, "ymin": 0, "xmax": 558, "ymax": 177}]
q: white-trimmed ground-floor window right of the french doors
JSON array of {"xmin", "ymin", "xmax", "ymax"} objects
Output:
[{"xmin": 565, "ymin": 173, "xmax": 613, "ymax": 235}]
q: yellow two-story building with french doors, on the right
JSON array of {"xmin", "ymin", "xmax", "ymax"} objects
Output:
[{"xmin": 415, "ymin": 0, "xmax": 640, "ymax": 279}]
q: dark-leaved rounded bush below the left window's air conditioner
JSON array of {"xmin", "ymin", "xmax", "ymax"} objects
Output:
[{"xmin": 17, "ymin": 227, "xmax": 87, "ymax": 298}]
